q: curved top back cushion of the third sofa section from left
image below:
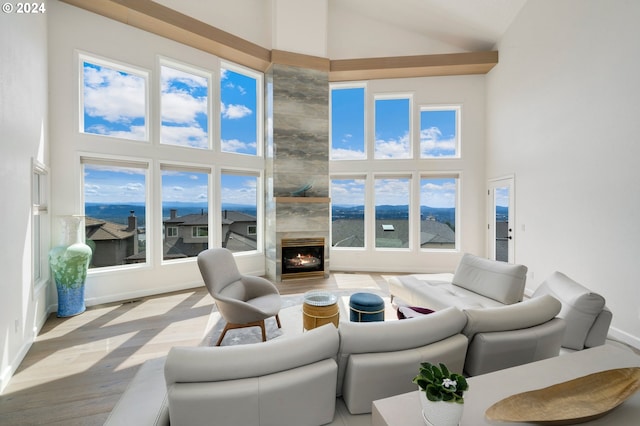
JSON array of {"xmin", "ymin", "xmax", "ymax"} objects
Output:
[{"xmin": 462, "ymin": 295, "xmax": 561, "ymax": 340}]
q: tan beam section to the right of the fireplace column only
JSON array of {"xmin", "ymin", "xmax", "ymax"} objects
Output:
[{"xmin": 329, "ymin": 51, "xmax": 498, "ymax": 81}]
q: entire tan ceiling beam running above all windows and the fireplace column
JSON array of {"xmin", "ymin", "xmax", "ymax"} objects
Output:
[{"xmin": 61, "ymin": 0, "xmax": 498, "ymax": 81}]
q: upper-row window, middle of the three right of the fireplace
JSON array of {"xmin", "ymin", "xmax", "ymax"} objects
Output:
[{"xmin": 375, "ymin": 97, "xmax": 412, "ymax": 159}]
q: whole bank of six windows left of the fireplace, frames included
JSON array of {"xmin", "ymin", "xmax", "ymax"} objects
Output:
[{"xmin": 77, "ymin": 53, "xmax": 264, "ymax": 273}]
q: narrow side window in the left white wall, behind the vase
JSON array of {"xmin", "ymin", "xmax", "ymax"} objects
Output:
[{"xmin": 31, "ymin": 160, "xmax": 49, "ymax": 285}]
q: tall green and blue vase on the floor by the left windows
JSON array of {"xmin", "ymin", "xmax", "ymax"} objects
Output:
[{"xmin": 49, "ymin": 216, "xmax": 92, "ymax": 317}]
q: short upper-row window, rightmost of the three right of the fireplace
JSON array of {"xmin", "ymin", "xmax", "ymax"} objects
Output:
[{"xmin": 420, "ymin": 107, "xmax": 460, "ymax": 158}]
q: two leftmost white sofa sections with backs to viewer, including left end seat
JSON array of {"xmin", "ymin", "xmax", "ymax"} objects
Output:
[{"xmin": 105, "ymin": 308, "xmax": 467, "ymax": 426}]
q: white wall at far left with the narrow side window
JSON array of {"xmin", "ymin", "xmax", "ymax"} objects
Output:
[{"xmin": 0, "ymin": 8, "xmax": 48, "ymax": 391}]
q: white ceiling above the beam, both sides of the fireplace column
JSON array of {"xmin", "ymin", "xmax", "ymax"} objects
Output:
[{"xmin": 155, "ymin": 0, "xmax": 527, "ymax": 52}]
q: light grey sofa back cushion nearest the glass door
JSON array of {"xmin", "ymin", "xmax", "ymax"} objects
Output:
[{"xmin": 452, "ymin": 253, "xmax": 527, "ymax": 305}]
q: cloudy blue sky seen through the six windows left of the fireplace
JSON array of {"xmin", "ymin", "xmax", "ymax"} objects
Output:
[{"xmin": 82, "ymin": 60, "xmax": 258, "ymax": 205}]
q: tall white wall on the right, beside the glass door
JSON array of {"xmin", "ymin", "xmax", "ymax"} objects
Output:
[{"xmin": 486, "ymin": 0, "xmax": 640, "ymax": 347}]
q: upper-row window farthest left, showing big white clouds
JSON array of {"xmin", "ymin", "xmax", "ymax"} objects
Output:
[{"xmin": 79, "ymin": 55, "xmax": 149, "ymax": 141}]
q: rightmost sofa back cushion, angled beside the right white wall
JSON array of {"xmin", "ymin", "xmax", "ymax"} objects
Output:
[{"xmin": 533, "ymin": 271, "xmax": 608, "ymax": 350}]
